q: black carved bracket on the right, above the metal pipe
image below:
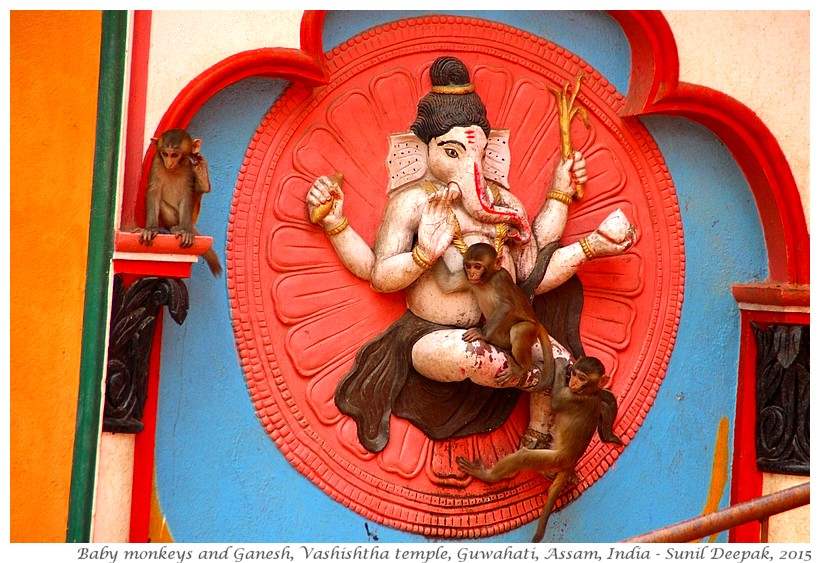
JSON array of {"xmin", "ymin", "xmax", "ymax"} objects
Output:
[{"xmin": 752, "ymin": 323, "xmax": 810, "ymax": 475}]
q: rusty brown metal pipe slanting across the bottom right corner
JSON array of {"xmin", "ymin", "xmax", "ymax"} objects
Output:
[{"xmin": 620, "ymin": 483, "xmax": 810, "ymax": 543}]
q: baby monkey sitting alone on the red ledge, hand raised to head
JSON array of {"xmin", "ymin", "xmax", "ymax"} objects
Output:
[{"xmin": 140, "ymin": 129, "xmax": 222, "ymax": 276}]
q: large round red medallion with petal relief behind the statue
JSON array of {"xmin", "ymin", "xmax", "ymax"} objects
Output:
[{"xmin": 227, "ymin": 17, "xmax": 684, "ymax": 538}]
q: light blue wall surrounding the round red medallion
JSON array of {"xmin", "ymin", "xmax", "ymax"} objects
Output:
[{"xmin": 156, "ymin": 11, "xmax": 767, "ymax": 542}]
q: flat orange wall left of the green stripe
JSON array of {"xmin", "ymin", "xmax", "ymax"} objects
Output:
[{"xmin": 10, "ymin": 11, "xmax": 103, "ymax": 542}]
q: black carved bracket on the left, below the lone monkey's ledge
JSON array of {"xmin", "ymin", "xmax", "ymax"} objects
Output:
[{"xmin": 103, "ymin": 275, "xmax": 188, "ymax": 434}]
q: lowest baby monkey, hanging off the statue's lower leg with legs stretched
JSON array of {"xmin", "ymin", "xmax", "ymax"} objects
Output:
[{"xmin": 457, "ymin": 356, "xmax": 623, "ymax": 542}]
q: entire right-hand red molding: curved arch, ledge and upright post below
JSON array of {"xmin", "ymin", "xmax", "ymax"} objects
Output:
[{"xmin": 609, "ymin": 16, "xmax": 810, "ymax": 532}]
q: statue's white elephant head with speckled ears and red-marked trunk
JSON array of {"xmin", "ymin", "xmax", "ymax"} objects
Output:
[{"xmin": 387, "ymin": 125, "xmax": 532, "ymax": 242}]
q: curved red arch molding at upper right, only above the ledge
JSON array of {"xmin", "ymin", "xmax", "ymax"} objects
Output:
[{"xmin": 609, "ymin": 10, "xmax": 809, "ymax": 284}]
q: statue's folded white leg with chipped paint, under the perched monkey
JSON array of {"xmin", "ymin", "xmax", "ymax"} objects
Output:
[{"xmin": 412, "ymin": 329, "xmax": 569, "ymax": 387}]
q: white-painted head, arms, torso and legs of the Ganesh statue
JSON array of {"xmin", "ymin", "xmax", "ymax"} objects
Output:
[{"xmin": 306, "ymin": 57, "xmax": 634, "ymax": 446}]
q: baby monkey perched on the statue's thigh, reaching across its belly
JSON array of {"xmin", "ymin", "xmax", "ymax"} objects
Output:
[{"xmin": 433, "ymin": 242, "xmax": 555, "ymax": 385}]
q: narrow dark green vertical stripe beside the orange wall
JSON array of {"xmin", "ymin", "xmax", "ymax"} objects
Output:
[{"xmin": 66, "ymin": 11, "xmax": 128, "ymax": 542}]
